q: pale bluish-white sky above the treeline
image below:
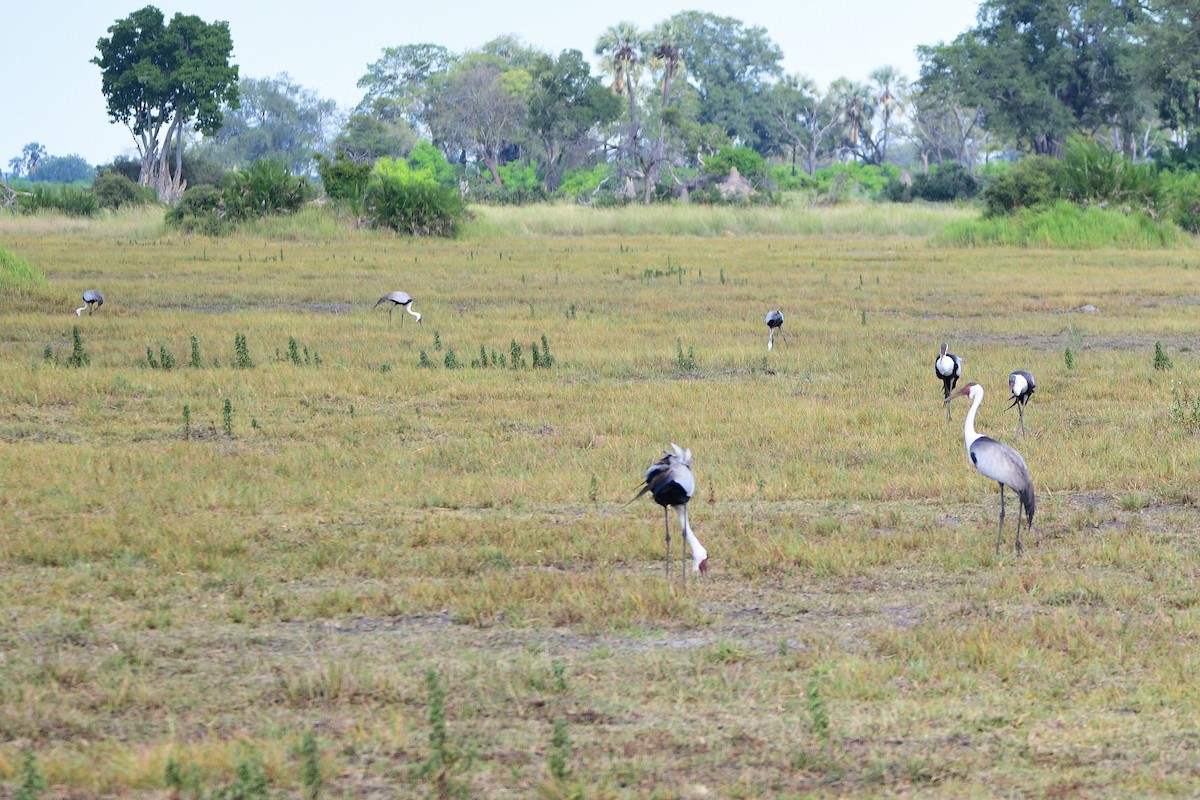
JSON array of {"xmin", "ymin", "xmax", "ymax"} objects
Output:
[{"xmin": 0, "ymin": 0, "xmax": 979, "ymax": 173}]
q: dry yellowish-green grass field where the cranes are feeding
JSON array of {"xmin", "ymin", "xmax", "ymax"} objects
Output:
[{"xmin": 0, "ymin": 203, "xmax": 1200, "ymax": 798}]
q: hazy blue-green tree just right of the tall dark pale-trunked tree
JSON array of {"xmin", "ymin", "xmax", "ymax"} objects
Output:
[{"xmin": 203, "ymin": 73, "xmax": 337, "ymax": 174}]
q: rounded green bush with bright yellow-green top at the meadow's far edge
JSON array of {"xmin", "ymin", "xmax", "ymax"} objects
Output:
[{"xmin": 366, "ymin": 174, "xmax": 467, "ymax": 236}]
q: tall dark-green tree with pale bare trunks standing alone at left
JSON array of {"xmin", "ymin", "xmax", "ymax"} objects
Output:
[{"xmin": 91, "ymin": 6, "xmax": 238, "ymax": 201}]
